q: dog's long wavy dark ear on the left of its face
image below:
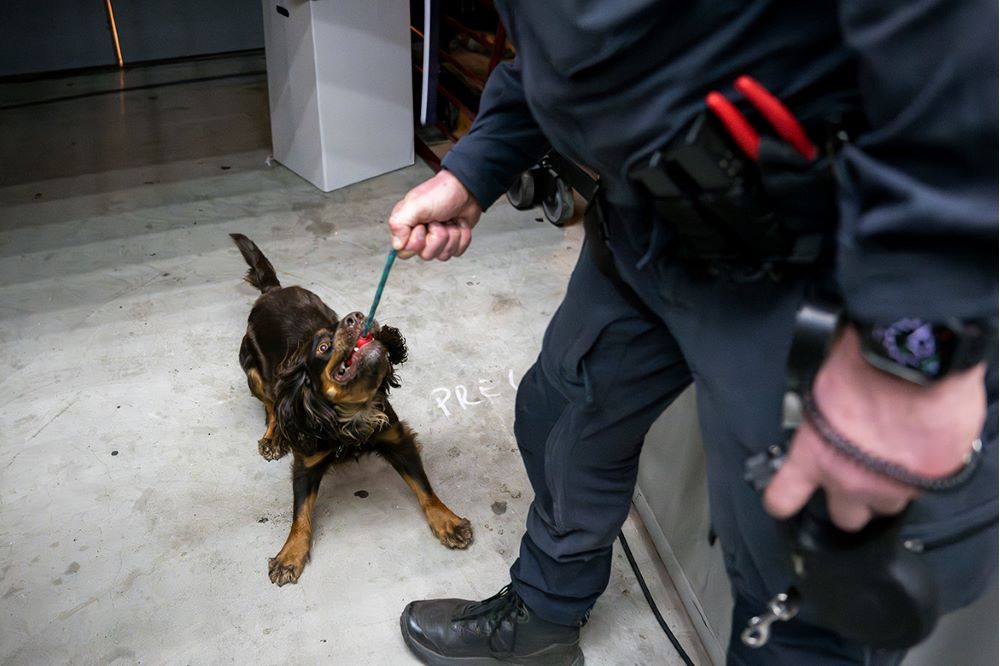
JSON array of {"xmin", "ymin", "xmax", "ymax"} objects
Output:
[{"xmin": 274, "ymin": 332, "xmax": 337, "ymax": 453}]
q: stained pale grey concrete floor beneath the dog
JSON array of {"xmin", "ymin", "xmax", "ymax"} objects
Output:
[{"xmin": 0, "ymin": 58, "xmax": 707, "ymax": 665}]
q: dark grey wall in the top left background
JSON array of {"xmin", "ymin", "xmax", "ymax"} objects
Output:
[{"xmin": 0, "ymin": 0, "xmax": 264, "ymax": 76}]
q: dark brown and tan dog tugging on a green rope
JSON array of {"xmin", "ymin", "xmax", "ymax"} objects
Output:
[{"xmin": 231, "ymin": 234, "xmax": 472, "ymax": 586}]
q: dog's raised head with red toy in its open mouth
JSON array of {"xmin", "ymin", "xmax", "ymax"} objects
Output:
[{"xmin": 274, "ymin": 312, "xmax": 406, "ymax": 448}]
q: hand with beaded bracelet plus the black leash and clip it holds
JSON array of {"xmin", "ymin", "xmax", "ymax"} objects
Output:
[{"xmin": 740, "ymin": 304, "xmax": 985, "ymax": 649}]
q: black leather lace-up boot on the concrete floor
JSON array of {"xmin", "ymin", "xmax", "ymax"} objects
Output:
[{"xmin": 399, "ymin": 585, "xmax": 583, "ymax": 666}]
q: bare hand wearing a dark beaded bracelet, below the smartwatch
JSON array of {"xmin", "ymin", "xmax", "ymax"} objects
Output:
[{"xmin": 764, "ymin": 327, "xmax": 986, "ymax": 531}]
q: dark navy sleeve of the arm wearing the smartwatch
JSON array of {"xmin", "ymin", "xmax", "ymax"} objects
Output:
[{"xmin": 838, "ymin": 0, "xmax": 998, "ymax": 321}]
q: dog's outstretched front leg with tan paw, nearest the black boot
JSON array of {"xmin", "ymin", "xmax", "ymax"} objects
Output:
[{"xmin": 375, "ymin": 421, "xmax": 472, "ymax": 548}]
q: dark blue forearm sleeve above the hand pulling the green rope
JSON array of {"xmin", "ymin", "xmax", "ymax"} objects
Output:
[{"xmin": 441, "ymin": 58, "xmax": 549, "ymax": 210}]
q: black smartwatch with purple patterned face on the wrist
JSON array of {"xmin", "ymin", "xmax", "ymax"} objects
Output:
[{"xmin": 854, "ymin": 317, "xmax": 997, "ymax": 384}]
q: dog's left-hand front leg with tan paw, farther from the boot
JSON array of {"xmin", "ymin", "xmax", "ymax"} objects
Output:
[{"xmin": 267, "ymin": 454, "xmax": 330, "ymax": 587}]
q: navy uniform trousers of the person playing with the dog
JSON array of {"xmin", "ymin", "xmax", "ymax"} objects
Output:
[{"xmin": 511, "ymin": 223, "xmax": 997, "ymax": 666}]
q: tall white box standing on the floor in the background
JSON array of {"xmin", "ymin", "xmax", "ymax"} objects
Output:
[{"xmin": 263, "ymin": 0, "xmax": 413, "ymax": 192}]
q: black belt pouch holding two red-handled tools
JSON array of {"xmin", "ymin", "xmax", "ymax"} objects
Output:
[{"xmin": 629, "ymin": 77, "xmax": 843, "ymax": 272}]
